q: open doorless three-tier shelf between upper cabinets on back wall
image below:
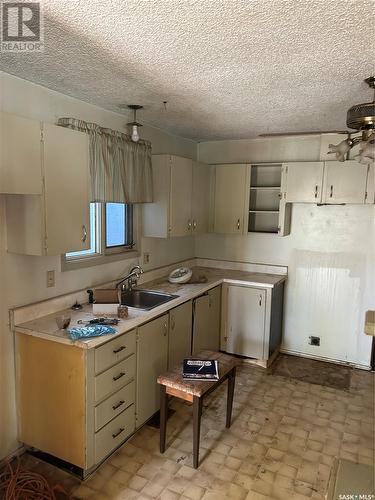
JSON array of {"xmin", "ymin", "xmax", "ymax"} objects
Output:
[{"xmin": 248, "ymin": 163, "xmax": 282, "ymax": 234}]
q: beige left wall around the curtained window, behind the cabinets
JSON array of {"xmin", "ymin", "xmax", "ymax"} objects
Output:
[{"xmin": 0, "ymin": 73, "xmax": 196, "ymax": 459}]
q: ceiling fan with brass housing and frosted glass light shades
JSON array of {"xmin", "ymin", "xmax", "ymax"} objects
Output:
[{"xmin": 259, "ymin": 76, "xmax": 375, "ymax": 164}]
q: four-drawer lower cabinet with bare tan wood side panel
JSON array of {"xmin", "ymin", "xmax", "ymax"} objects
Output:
[{"xmin": 16, "ymin": 330, "xmax": 136, "ymax": 475}]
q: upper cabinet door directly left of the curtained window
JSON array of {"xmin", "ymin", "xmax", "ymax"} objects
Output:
[{"xmin": 43, "ymin": 124, "xmax": 90, "ymax": 255}]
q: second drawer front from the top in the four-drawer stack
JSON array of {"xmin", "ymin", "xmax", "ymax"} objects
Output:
[{"xmin": 95, "ymin": 354, "xmax": 135, "ymax": 401}]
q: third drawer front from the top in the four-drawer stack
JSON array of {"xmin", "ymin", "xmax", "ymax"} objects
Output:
[{"xmin": 95, "ymin": 381, "xmax": 135, "ymax": 432}]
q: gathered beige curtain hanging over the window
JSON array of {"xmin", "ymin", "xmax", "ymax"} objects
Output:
[{"xmin": 57, "ymin": 118, "xmax": 152, "ymax": 203}]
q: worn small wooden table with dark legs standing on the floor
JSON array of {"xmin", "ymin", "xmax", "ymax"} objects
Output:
[{"xmin": 158, "ymin": 351, "xmax": 238, "ymax": 469}]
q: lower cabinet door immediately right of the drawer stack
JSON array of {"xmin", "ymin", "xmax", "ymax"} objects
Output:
[{"xmin": 136, "ymin": 314, "xmax": 168, "ymax": 427}]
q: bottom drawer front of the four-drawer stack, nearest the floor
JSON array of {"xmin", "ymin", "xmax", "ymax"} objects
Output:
[{"xmin": 95, "ymin": 405, "xmax": 135, "ymax": 463}]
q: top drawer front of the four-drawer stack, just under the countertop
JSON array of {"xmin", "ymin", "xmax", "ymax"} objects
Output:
[{"xmin": 95, "ymin": 330, "xmax": 135, "ymax": 373}]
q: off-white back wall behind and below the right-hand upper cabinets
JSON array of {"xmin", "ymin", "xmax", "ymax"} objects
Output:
[{"xmin": 195, "ymin": 136, "xmax": 375, "ymax": 366}]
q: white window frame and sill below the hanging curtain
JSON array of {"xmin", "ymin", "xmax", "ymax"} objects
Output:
[{"xmin": 61, "ymin": 203, "xmax": 140, "ymax": 271}]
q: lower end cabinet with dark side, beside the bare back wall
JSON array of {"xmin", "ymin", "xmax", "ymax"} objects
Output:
[{"xmin": 221, "ymin": 282, "xmax": 284, "ymax": 366}]
